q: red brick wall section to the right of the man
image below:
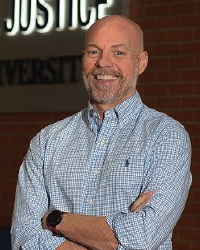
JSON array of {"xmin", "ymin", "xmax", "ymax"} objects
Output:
[{"xmin": 130, "ymin": 0, "xmax": 200, "ymax": 250}]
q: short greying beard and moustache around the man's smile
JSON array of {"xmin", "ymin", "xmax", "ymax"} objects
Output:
[{"xmin": 83, "ymin": 63, "xmax": 139, "ymax": 104}]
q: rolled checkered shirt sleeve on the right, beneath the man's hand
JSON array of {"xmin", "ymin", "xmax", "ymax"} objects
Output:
[{"xmin": 107, "ymin": 124, "xmax": 191, "ymax": 250}]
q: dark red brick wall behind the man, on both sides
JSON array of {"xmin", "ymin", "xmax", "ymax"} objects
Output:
[{"xmin": 0, "ymin": 0, "xmax": 200, "ymax": 250}]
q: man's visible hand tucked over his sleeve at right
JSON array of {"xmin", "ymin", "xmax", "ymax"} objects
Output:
[{"xmin": 130, "ymin": 191, "xmax": 153, "ymax": 212}]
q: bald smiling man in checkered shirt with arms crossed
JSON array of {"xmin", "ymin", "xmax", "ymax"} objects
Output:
[{"xmin": 12, "ymin": 15, "xmax": 191, "ymax": 250}]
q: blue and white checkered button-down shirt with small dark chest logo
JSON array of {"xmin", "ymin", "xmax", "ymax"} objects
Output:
[{"xmin": 12, "ymin": 93, "xmax": 191, "ymax": 250}]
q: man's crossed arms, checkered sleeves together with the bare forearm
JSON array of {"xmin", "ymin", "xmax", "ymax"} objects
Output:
[{"xmin": 12, "ymin": 120, "xmax": 191, "ymax": 250}]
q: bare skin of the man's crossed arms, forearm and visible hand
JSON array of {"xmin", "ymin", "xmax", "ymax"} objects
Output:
[{"xmin": 42, "ymin": 192, "xmax": 153, "ymax": 250}]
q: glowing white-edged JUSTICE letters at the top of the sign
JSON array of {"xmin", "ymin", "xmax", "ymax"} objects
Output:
[{"xmin": 3, "ymin": 0, "xmax": 114, "ymax": 36}]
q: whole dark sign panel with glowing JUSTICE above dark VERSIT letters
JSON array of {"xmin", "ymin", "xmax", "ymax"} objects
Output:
[{"xmin": 0, "ymin": 0, "xmax": 130, "ymax": 112}]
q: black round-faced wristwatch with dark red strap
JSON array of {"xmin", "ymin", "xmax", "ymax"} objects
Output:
[{"xmin": 46, "ymin": 210, "xmax": 64, "ymax": 237}]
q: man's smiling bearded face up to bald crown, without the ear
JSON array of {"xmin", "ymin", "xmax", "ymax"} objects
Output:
[{"xmin": 82, "ymin": 16, "xmax": 148, "ymax": 109}]
